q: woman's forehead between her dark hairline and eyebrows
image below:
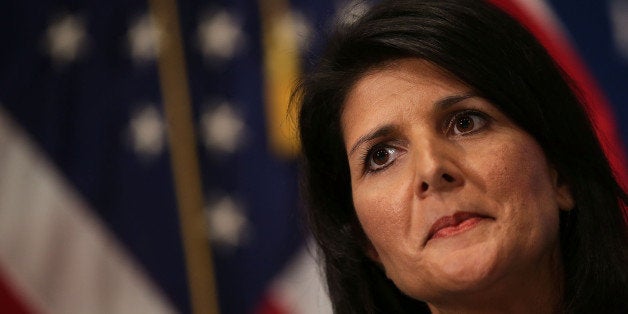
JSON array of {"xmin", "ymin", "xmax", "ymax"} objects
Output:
[{"xmin": 341, "ymin": 59, "xmax": 471, "ymax": 135}]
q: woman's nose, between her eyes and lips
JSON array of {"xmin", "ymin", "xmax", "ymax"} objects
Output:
[{"xmin": 415, "ymin": 141, "xmax": 464, "ymax": 198}]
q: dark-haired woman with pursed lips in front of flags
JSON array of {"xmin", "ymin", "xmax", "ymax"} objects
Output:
[{"xmin": 296, "ymin": 0, "xmax": 628, "ymax": 313}]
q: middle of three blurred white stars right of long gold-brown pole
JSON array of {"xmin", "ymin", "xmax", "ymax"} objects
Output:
[{"xmin": 201, "ymin": 102, "xmax": 245, "ymax": 153}]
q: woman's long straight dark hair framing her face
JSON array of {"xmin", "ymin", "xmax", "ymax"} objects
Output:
[{"xmin": 295, "ymin": 0, "xmax": 628, "ymax": 313}]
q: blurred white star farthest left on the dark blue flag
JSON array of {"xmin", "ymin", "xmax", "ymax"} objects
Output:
[{"xmin": 46, "ymin": 14, "xmax": 87, "ymax": 65}]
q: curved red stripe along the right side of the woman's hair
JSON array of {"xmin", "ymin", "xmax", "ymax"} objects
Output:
[{"xmin": 489, "ymin": 0, "xmax": 628, "ymax": 187}]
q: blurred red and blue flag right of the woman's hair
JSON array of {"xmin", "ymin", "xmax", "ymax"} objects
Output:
[{"xmin": 490, "ymin": 0, "xmax": 628, "ymax": 187}]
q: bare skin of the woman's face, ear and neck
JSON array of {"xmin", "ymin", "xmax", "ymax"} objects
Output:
[{"xmin": 341, "ymin": 59, "xmax": 573, "ymax": 313}]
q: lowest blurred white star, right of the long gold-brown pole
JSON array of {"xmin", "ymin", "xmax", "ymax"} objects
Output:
[{"xmin": 206, "ymin": 195, "xmax": 249, "ymax": 248}]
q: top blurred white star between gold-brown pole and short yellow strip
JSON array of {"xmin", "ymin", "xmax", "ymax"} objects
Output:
[{"xmin": 196, "ymin": 10, "xmax": 246, "ymax": 62}]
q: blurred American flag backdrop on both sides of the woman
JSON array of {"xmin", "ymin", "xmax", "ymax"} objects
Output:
[{"xmin": 0, "ymin": 0, "xmax": 628, "ymax": 314}]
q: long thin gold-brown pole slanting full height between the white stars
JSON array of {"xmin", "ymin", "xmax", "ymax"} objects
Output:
[{"xmin": 149, "ymin": 0, "xmax": 219, "ymax": 314}]
